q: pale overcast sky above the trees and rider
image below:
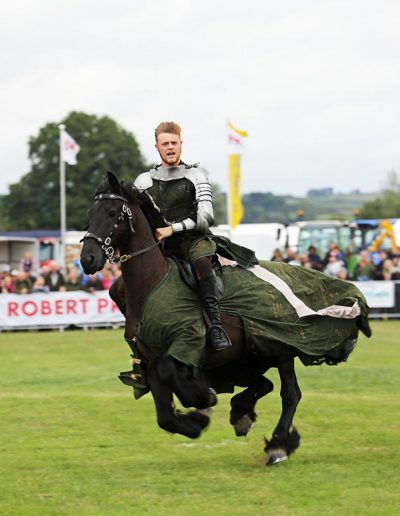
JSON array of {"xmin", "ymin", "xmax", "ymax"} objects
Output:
[{"xmin": 0, "ymin": 0, "xmax": 400, "ymax": 196}]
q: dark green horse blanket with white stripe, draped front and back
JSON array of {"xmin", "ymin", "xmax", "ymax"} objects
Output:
[{"xmin": 136, "ymin": 260, "xmax": 370, "ymax": 366}]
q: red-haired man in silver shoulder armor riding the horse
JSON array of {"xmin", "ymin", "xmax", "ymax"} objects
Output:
[{"xmin": 134, "ymin": 122, "xmax": 231, "ymax": 351}]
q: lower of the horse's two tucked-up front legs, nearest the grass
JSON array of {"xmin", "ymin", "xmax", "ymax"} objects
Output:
[{"xmin": 147, "ymin": 363, "xmax": 210, "ymax": 439}]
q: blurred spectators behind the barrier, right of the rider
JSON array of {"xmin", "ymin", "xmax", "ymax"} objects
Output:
[{"xmin": 271, "ymin": 242, "xmax": 400, "ymax": 281}]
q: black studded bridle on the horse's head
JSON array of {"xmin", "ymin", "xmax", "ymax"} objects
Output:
[{"xmin": 81, "ymin": 193, "xmax": 162, "ymax": 263}]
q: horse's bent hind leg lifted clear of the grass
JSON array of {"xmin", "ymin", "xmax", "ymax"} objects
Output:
[{"xmin": 229, "ymin": 375, "xmax": 274, "ymax": 436}]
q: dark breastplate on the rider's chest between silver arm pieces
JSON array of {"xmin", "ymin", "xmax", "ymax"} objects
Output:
[{"xmin": 147, "ymin": 177, "xmax": 196, "ymax": 223}]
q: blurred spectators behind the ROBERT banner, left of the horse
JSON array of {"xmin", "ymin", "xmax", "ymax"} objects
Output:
[{"xmin": 0, "ymin": 253, "xmax": 121, "ymax": 294}]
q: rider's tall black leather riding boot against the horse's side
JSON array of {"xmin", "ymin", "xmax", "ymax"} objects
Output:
[{"xmin": 199, "ymin": 271, "xmax": 232, "ymax": 351}]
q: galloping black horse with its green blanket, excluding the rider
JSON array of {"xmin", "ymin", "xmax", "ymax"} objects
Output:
[{"xmin": 81, "ymin": 172, "xmax": 371, "ymax": 464}]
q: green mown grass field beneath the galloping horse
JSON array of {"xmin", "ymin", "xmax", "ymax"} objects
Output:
[{"xmin": 0, "ymin": 321, "xmax": 400, "ymax": 515}]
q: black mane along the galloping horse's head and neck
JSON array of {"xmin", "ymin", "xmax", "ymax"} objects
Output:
[{"xmin": 95, "ymin": 173, "xmax": 165, "ymax": 229}]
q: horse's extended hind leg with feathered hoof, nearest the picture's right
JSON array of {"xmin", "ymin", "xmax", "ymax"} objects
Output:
[{"xmin": 265, "ymin": 358, "xmax": 301, "ymax": 465}]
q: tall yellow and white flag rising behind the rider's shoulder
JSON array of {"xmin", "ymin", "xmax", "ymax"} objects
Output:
[{"xmin": 228, "ymin": 122, "xmax": 247, "ymax": 229}]
